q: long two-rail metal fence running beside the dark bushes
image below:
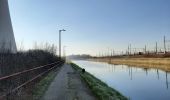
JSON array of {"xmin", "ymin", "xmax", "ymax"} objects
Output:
[{"xmin": 0, "ymin": 61, "xmax": 63, "ymax": 100}]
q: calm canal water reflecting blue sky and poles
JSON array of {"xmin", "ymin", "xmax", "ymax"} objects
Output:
[{"xmin": 73, "ymin": 61, "xmax": 170, "ymax": 100}]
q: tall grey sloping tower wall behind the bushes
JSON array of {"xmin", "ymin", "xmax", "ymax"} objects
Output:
[{"xmin": 0, "ymin": 0, "xmax": 17, "ymax": 53}]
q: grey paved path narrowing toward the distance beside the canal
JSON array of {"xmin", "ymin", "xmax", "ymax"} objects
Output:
[{"xmin": 42, "ymin": 64, "xmax": 96, "ymax": 100}]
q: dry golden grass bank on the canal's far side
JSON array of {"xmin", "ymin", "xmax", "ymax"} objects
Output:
[{"xmin": 92, "ymin": 58, "xmax": 170, "ymax": 71}]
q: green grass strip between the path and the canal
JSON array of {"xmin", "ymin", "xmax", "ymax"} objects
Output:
[{"xmin": 71, "ymin": 63, "xmax": 128, "ymax": 100}]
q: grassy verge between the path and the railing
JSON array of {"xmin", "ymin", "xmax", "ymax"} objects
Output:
[{"xmin": 33, "ymin": 71, "xmax": 57, "ymax": 100}]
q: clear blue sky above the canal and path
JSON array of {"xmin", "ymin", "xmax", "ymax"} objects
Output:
[{"xmin": 9, "ymin": 0, "xmax": 170, "ymax": 55}]
